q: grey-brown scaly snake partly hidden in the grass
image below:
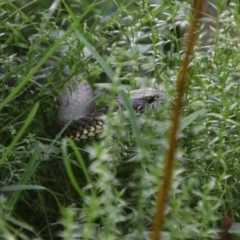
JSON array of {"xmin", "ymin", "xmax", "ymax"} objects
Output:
[{"xmin": 0, "ymin": 58, "xmax": 164, "ymax": 142}]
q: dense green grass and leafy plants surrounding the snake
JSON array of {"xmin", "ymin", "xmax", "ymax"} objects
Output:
[{"xmin": 0, "ymin": 0, "xmax": 240, "ymax": 240}]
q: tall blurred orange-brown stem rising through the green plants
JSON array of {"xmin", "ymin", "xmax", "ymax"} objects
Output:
[{"xmin": 151, "ymin": 0, "xmax": 202, "ymax": 240}]
